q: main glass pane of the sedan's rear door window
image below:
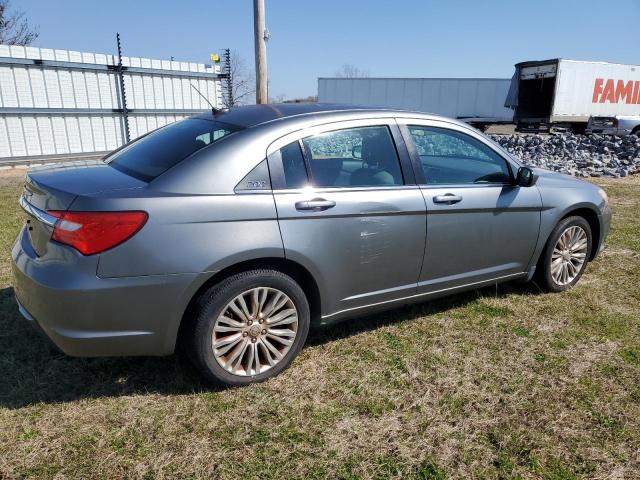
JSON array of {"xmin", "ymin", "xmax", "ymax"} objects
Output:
[{"xmin": 302, "ymin": 126, "xmax": 403, "ymax": 187}]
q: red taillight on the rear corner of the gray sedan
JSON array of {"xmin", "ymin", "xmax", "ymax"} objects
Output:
[{"xmin": 48, "ymin": 211, "xmax": 149, "ymax": 255}]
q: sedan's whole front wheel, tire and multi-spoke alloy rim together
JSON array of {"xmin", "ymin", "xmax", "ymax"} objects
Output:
[{"xmin": 538, "ymin": 216, "xmax": 592, "ymax": 292}]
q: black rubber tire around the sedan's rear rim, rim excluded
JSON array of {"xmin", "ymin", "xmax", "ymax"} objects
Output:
[{"xmin": 187, "ymin": 269, "xmax": 310, "ymax": 386}]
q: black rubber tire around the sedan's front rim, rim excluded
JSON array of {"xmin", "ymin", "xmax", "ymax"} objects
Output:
[{"xmin": 536, "ymin": 216, "xmax": 593, "ymax": 292}]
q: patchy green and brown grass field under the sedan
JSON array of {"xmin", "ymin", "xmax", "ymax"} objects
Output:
[{"xmin": 0, "ymin": 172, "xmax": 640, "ymax": 479}]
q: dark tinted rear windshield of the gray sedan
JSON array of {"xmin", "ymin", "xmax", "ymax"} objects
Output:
[{"xmin": 105, "ymin": 118, "xmax": 241, "ymax": 182}]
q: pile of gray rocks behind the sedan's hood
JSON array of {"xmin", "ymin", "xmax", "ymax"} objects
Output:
[{"xmin": 489, "ymin": 134, "xmax": 640, "ymax": 177}]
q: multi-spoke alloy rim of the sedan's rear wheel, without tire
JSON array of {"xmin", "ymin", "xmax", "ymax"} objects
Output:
[{"xmin": 212, "ymin": 287, "xmax": 298, "ymax": 376}]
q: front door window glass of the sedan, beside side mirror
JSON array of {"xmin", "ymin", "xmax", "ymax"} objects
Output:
[{"xmin": 409, "ymin": 125, "xmax": 511, "ymax": 185}]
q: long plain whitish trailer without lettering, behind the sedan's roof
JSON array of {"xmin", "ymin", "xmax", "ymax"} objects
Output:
[{"xmin": 318, "ymin": 78, "xmax": 513, "ymax": 128}]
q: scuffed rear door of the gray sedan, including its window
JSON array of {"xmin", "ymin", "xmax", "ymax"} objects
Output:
[{"xmin": 267, "ymin": 119, "xmax": 426, "ymax": 320}]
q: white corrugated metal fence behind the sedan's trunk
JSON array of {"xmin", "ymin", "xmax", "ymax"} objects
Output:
[{"xmin": 0, "ymin": 45, "xmax": 222, "ymax": 163}]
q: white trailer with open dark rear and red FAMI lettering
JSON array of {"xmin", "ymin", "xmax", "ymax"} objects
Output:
[{"xmin": 506, "ymin": 59, "xmax": 640, "ymax": 133}]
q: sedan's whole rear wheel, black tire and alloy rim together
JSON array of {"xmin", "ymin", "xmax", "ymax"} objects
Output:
[{"xmin": 189, "ymin": 270, "xmax": 310, "ymax": 385}]
